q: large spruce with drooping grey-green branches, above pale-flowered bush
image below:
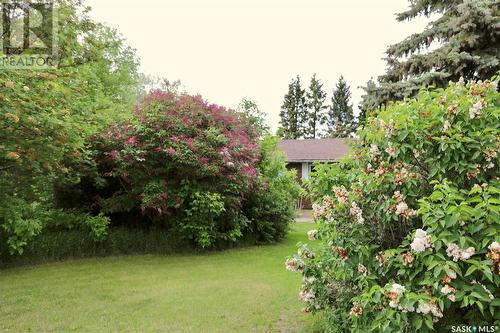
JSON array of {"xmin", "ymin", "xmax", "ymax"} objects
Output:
[{"xmin": 361, "ymin": 0, "xmax": 500, "ymax": 110}]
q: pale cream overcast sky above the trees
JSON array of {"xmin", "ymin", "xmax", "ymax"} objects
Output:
[{"xmin": 87, "ymin": 0, "xmax": 428, "ymax": 130}]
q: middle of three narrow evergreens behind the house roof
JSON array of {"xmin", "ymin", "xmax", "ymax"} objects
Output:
[{"xmin": 306, "ymin": 74, "xmax": 327, "ymax": 139}]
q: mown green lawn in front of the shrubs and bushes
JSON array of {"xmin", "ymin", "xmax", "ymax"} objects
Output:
[{"xmin": 0, "ymin": 223, "xmax": 320, "ymax": 333}]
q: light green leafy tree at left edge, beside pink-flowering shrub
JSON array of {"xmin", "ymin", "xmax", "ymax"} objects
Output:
[{"xmin": 0, "ymin": 0, "xmax": 138, "ymax": 253}]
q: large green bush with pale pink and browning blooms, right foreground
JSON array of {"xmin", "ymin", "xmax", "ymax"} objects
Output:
[{"xmin": 286, "ymin": 80, "xmax": 500, "ymax": 332}]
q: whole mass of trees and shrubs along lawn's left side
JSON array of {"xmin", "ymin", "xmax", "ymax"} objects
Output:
[{"xmin": 0, "ymin": 0, "xmax": 298, "ymax": 258}]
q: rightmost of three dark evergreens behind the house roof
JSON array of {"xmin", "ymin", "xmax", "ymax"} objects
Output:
[{"xmin": 326, "ymin": 76, "xmax": 356, "ymax": 138}]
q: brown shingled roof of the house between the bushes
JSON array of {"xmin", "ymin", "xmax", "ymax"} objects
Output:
[{"xmin": 279, "ymin": 138, "xmax": 350, "ymax": 162}]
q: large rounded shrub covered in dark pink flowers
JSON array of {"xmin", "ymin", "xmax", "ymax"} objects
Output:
[{"xmin": 76, "ymin": 91, "xmax": 260, "ymax": 247}]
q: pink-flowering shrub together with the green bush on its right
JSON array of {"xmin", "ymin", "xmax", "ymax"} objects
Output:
[{"xmin": 58, "ymin": 90, "xmax": 296, "ymax": 247}]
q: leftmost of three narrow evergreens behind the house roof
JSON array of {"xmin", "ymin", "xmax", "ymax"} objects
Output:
[{"xmin": 278, "ymin": 75, "xmax": 307, "ymax": 139}]
